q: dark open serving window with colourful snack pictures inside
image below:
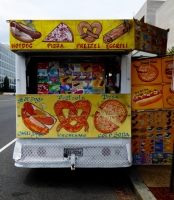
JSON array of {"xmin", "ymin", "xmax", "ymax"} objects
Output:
[{"xmin": 26, "ymin": 56, "xmax": 121, "ymax": 94}]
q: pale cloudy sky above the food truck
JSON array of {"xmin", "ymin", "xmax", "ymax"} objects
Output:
[{"xmin": 0, "ymin": 0, "xmax": 146, "ymax": 44}]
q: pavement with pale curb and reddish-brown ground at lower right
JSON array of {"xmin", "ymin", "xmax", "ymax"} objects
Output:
[{"xmin": 127, "ymin": 165, "xmax": 174, "ymax": 200}]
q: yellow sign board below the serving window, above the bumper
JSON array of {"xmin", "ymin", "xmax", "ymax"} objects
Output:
[{"xmin": 16, "ymin": 94, "xmax": 131, "ymax": 138}]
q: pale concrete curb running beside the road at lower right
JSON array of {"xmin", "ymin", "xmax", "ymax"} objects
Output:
[{"xmin": 127, "ymin": 167, "xmax": 157, "ymax": 200}]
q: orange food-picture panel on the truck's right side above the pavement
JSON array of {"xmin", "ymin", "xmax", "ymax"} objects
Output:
[{"xmin": 132, "ymin": 56, "xmax": 174, "ymax": 165}]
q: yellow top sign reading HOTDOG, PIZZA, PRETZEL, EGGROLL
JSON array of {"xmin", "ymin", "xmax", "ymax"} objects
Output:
[{"xmin": 10, "ymin": 20, "xmax": 135, "ymax": 50}]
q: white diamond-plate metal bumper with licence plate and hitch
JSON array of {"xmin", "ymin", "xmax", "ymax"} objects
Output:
[{"xmin": 13, "ymin": 139, "xmax": 132, "ymax": 169}]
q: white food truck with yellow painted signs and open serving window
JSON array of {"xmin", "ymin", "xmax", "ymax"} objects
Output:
[{"xmin": 9, "ymin": 19, "xmax": 167, "ymax": 170}]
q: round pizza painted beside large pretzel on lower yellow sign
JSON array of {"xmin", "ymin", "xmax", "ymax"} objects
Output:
[{"xmin": 94, "ymin": 100, "xmax": 127, "ymax": 134}]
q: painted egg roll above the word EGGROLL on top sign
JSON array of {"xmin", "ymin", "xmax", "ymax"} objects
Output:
[{"xmin": 103, "ymin": 21, "xmax": 132, "ymax": 44}]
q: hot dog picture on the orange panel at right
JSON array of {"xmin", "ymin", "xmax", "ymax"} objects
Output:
[{"xmin": 133, "ymin": 90, "xmax": 162, "ymax": 106}]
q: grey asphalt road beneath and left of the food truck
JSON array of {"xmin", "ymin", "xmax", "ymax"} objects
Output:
[{"xmin": 0, "ymin": 95, "xmax": 134, "ymax": 200}]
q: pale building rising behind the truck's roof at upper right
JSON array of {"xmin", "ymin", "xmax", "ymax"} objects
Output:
[{"xmin": 135, "ymin": 0, "xmax": 174, "ymax": 49}]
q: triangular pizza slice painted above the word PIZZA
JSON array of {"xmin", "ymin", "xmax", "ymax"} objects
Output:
[{"xmin": 43, "ymin": 22, "xmax": 74, "ymax": 42}]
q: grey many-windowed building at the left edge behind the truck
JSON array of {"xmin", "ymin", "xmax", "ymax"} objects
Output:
[{"xmin": 0, "ymin": 44, "xmax": 16, "ymax": 89}]
